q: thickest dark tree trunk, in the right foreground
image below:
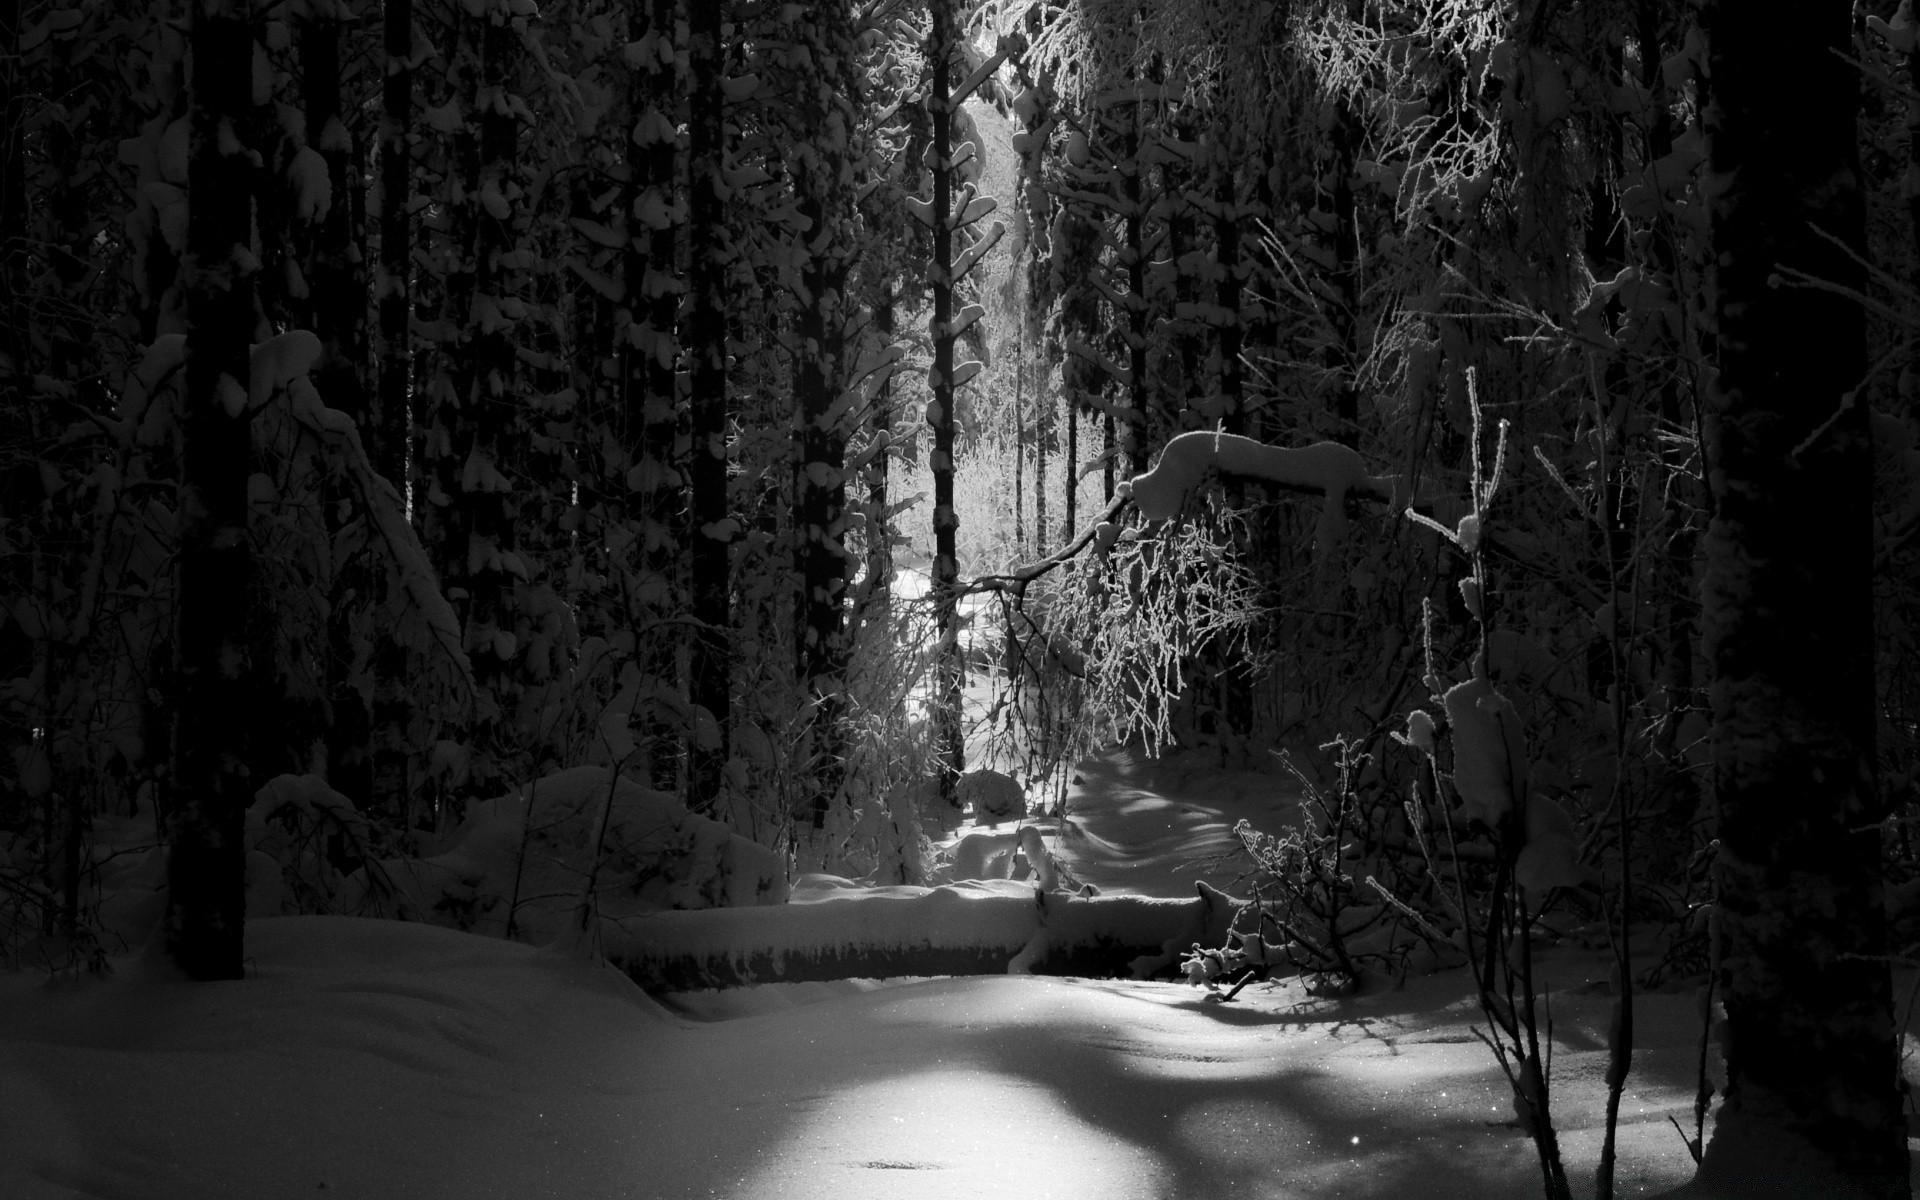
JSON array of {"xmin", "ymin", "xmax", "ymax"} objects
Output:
[{"xmin": 1697, "ymin": 0, "xmax": 1908, "ymax": 1198}]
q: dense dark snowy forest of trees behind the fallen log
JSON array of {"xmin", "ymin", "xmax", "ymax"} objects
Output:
[{"xmin": 0, "ymin": 0, "xmax": 1920, "ymax": 952}]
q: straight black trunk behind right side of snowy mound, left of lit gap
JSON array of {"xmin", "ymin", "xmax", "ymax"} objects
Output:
[{"xmin": 685, "ymin": 4, "xmax": 733, "ymax": 812}]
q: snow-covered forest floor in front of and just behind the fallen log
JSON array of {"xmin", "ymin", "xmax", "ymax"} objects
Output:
[{"xmin": 0, "ymin": 756, "xmax": 1827, "ymax": 1200}]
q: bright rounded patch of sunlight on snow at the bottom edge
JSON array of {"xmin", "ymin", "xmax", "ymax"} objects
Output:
[{"xmin": 728, "ymin": 1069, "xmax": 1167, "ymax": 1200}]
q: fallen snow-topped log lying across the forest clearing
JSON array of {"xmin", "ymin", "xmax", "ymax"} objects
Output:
[{"xmin": 605, "ymin": 879, "xmax": 1240, "ymax": 991}]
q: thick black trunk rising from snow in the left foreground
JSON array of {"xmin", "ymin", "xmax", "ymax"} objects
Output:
[{"xmin": 165, "ymin": 0, "xmax": 255, "ymax": 979}]
